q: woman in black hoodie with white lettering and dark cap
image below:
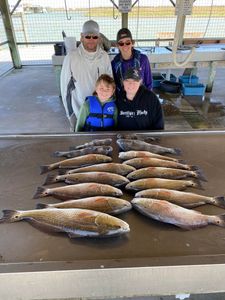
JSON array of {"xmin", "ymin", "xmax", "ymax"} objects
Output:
[{"xmin": 117, "ymin": 68, "xmax": 164, "ymax": 130}]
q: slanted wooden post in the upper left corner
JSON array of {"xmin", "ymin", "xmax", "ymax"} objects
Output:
[{"xmin": 0, "ymin": 0, "xmax": 22, "ymax": 69}]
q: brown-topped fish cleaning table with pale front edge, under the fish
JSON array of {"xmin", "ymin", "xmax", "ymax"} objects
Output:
[{"xmin": 0, "ymin": 132, "xmax": 225, "ymax": 300}]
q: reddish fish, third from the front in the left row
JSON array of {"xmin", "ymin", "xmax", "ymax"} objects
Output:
[{"xmin": 33, "ymin": 182, "xmax": 123, "ymax": 200}]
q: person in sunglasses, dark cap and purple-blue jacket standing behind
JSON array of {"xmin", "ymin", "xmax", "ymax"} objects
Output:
[{"xmin": 112, "ymin": 28, "xmax": 152, "ymax": 95}]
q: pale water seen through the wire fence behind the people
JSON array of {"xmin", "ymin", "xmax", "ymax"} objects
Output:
[{"xmin": 10, "ymin": 12, "xmax": 225, "ymax": 42}]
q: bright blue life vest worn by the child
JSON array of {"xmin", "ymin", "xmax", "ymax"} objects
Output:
[{"xmin": 85, "ymin": 96, "xmax": 116, "ymax": 131}]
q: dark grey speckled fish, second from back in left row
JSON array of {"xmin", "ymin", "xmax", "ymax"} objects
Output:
[{"xmin": 53, "ymin": 146, "xmax": 113, "ymax": 158}]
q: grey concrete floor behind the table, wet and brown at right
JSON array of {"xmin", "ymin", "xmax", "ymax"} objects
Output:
[{"xmin": 0, "ymin": 66, "xmax": 225, "ymax": 300}]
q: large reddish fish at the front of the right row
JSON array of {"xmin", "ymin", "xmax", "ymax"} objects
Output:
[{"xmin": 131, "ymin": 198, "xmax": 225, "ymax": 230}]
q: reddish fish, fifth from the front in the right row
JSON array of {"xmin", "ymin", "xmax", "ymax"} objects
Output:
[{"xmin": 123, "ymin": 157, "xmax": 199, "ymax": 171}]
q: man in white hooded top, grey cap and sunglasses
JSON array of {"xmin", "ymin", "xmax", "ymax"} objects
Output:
[{"xmin": 61, "ymin": 20, "xmax": 112, "ymax": 131}]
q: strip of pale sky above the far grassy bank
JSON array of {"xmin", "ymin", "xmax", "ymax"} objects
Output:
[{"xmin": 8, "ymin": 0, "xmax": 225, "ymax": 8}]
